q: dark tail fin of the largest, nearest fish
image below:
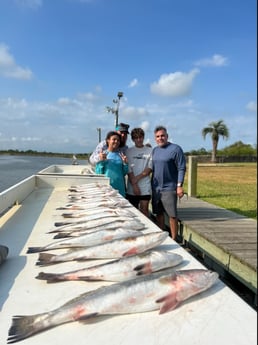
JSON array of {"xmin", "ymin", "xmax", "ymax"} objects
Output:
[{"xmin": 7, "ymin": 313, "xmax": 47, "ymax": 344}]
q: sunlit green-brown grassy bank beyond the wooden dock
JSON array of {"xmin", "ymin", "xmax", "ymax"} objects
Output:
[{"xmin": 184, "ymin": 163, "xmax": 257, "ymax": 219}]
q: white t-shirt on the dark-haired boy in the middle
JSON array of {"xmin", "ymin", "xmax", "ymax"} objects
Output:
[{"xmin": 126, "ymin": 146, "xmax": 152, "ymax": 195}]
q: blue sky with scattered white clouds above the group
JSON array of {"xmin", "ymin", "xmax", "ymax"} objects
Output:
[{"xmin": 0, "ymin": 0, "xmax": 257, "ymax": 153}]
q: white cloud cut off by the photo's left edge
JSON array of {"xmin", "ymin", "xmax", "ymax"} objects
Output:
[{"xmin": 0, "ymin": 43, "xmax": 33, "ymax": 80}]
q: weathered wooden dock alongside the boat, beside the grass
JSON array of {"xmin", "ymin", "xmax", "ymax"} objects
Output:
[{"xmin": 175, "ymin": 196, "xmax": 257, "ymax": 304}]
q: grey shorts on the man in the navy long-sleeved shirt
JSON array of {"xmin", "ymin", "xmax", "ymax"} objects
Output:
[{"xmin": 152, "ymin": 190, "xmax": 177, "ymax": 218}]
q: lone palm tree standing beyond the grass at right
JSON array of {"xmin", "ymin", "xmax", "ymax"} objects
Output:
[{"xmin": 202, "ymin": 120, "xmax": 229, "ymax": 163}]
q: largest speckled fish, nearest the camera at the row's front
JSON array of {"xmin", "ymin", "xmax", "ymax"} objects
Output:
[{"xmin": 8, "ymin": 268, "xmax": 218, "ymax": 344}]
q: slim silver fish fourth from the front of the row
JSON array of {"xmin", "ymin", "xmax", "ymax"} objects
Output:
[{"xmin": 27, "ymin": 228, "xmax": 141, "ymax": 254}]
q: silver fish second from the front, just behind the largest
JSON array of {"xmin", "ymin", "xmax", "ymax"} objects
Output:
[{"xmin": 36, "ymin": 250, "xmax": 183, "ymax": 283}]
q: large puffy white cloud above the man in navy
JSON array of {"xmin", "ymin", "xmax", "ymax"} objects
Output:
[{"xmin": 150, "ymin": 68, "xmax": 200, "ymax": 97}]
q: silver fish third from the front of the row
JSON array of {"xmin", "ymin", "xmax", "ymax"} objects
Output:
[{"xmin": 36, "ymin": 231, "xmax": 168, "ymax": 266}]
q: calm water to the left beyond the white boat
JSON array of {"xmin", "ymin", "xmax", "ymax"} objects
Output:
[{"xmin": 0, "ymin": 155, "xmax": 85, "ymax": 192}]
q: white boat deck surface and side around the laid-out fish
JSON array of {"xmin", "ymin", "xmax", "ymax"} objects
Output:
[{"xmin": 0, "ymin": 175, "xmax": 257, "ymax": 345}]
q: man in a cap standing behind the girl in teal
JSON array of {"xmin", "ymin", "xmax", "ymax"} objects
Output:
[{"xmin": 89, "ymin": 123, "xmax": 130, "ymax": 166}]
